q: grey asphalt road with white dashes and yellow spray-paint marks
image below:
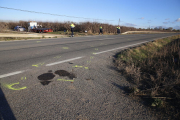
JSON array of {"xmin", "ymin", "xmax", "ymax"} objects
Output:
[{"xmin": 0, "ymin": 33, "xmax": 179, "ymax": 120}]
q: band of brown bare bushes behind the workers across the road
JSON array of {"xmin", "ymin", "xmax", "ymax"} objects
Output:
[{"xmin": 0, "ymin": 21, "xmax": 178, "ymax": 33}]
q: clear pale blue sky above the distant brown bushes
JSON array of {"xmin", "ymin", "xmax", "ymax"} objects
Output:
[{"xmin": 0, "ymin": 0, "xmax": 180, "ymax": 29}]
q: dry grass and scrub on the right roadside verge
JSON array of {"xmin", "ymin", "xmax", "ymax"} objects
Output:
[{"xmin": 116, "ymin": 35, "xmax": 180, "ymax": 119}]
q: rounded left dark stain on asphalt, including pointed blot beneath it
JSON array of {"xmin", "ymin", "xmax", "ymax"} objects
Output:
[{"xmin": 38, "ymin": 73, "xmax": 55, "ymax": 85}]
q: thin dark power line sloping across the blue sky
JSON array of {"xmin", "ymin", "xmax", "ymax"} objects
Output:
[{"xmin": 0, "ymin": 6, "xmax": 114, "ymax": 21}]
